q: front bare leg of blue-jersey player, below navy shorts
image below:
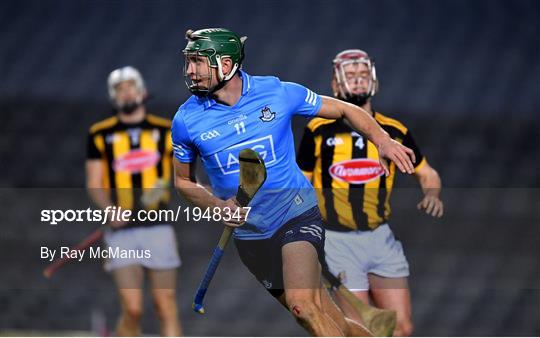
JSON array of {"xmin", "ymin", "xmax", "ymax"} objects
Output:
[{"xmin": 281, "ymin": 241, "xmax": 344, "ymax": 337}]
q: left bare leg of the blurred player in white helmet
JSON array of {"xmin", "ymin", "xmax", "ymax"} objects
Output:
[{"xmin": 112, "ymin": 265, "xmax": 144, "ymax": 337}]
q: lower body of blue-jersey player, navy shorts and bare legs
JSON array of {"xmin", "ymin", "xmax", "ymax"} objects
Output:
[{"xmin": 235, "ymin": 208, "xmax": 370, "ymax": 336}]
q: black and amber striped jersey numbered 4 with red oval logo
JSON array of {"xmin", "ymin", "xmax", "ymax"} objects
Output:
[{"xmin": 297, "ymin": 113, "xmax": 426, "ymax": 231}]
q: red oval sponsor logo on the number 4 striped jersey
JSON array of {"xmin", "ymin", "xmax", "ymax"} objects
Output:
[{"xmin": 328, "ymin": 158, "xmax": 384, "ymax": 184}]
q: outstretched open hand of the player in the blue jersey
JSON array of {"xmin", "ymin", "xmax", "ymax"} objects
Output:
[{"xmin": 377, "ymin": 137, "xmax": 416, "ymax": 176}]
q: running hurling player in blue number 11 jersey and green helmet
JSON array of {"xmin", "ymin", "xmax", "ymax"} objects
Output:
[{"xmin": 172, "ymin": 28, "xmax": 415, "ymax": 336}]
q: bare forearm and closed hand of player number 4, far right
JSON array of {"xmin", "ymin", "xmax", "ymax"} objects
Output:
[{"xmin": 415, "ymin": 162, "xmax": 444, "ymax": 218}]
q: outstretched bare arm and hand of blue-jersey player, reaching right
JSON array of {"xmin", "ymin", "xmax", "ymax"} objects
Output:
[{"xmin": 317, "ymin": 96, "xmax": 416, "ymax": 175}]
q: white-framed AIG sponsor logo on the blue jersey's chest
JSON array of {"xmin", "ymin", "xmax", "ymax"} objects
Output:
[{"xmin": 214, "ymin": 135, "xmax": 277, "ymax": 175}]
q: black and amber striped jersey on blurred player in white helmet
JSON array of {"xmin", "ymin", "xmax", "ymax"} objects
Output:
[{"xmin": 87, "ymin": 114, "xmax": 172, "ymax": 219}]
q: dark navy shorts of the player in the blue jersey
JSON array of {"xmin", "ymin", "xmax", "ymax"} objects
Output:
[{"xmin": 234, "ymin": 207, "xmax": 325, "ymax": 297}]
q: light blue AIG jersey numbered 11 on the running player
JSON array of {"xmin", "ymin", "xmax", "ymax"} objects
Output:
[{"xmin": 172, "ymin": 71, "xmax": 322, "ymax": 239}]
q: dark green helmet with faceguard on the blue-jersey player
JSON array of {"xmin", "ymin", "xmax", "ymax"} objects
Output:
[{"xmin": 183, "ymin": 28, "xmax": 247, "ymax": 95}]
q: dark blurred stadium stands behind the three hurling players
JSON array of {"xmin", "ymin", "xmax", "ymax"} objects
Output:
[{"xmin": 0, "ymin": 0, "xmax": 540, "ymax": 336}]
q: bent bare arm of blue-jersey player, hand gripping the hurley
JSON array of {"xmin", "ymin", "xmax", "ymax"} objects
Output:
[{"xmin": 173, "ymin": 158, "xmax": 245, "ymax": 227}]
